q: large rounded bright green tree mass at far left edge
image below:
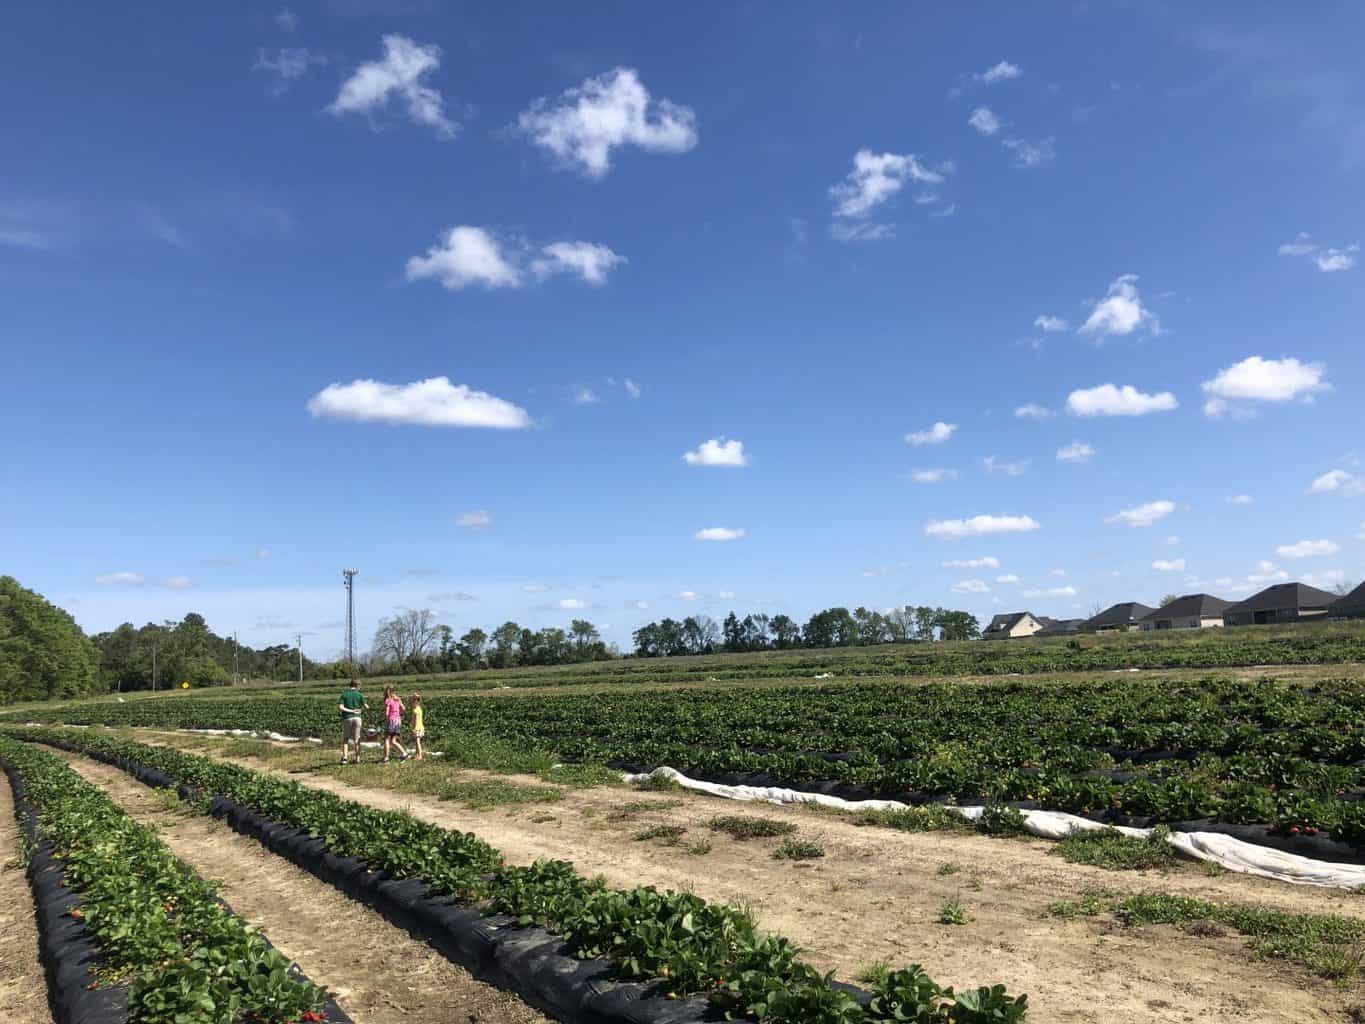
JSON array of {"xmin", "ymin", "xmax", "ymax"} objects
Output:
[{"xmin": 0, "ymin": 576, "xmax": 100, "ymax": 705}]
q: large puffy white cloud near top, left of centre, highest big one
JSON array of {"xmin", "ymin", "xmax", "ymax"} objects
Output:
[{"xmin": 517, "ymin": 67, "xmax": 698, "ymax": 177}]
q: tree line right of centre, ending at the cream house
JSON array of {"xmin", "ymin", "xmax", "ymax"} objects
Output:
[{"xmin": 632, "ymin": 605, "xmax": 981, "ymax": 658}]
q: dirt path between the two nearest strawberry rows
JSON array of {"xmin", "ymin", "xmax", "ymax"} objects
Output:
[{"xmin": 58, "ymin": 755, "xmax": 546, "ymax": 1024}]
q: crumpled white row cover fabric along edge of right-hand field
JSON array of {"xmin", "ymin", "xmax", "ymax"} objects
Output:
[{"xmin": 624, "ymin": 767, "xmax": 1365, "ymax": 889}]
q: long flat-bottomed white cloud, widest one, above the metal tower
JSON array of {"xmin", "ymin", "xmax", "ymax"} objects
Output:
[{"xmin": 308, "ymin": 377, "xmax": 531, "ymax": 430}]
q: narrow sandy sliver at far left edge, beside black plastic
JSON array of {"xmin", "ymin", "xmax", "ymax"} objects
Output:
[{"xmin": 0, "ymin": 776, "xmax": 52, "ymax": 1024}]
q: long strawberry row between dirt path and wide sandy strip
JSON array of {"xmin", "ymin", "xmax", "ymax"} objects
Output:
[{"xmin": 11, "ymin": 729, "xmax": 1028, "ymax": 1024}]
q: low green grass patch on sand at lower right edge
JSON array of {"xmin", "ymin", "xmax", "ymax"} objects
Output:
[{"xmin": 1048, "ymin": 893, "xmax": 1365, "ymax": 984}]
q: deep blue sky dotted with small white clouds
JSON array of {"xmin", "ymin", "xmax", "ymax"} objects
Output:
[{"xmin": 0, "ymin": 0, "xmax": 1365, "ymax": 657}]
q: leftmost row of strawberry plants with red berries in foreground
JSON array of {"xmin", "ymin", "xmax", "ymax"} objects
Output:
[{"xmin": 0, "ymin": 736, "xmax": 338, "ymax": 1024}]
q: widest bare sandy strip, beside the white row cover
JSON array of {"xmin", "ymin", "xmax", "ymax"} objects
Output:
[{"xmin": 101, "ymin": 737, "xmax": 1365, "ymax": 1024}]
